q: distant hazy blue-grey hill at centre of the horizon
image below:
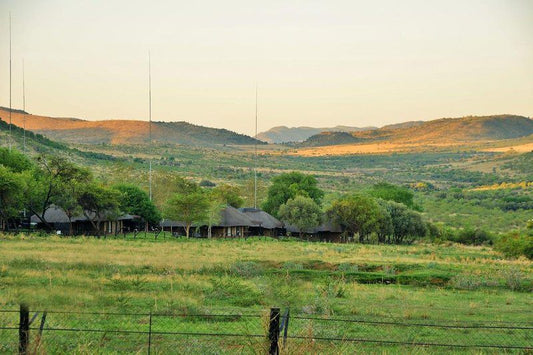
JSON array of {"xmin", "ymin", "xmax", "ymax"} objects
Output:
[{"xmin": 257, "ymin": 126, "xmax": 376, "ymax": 143}]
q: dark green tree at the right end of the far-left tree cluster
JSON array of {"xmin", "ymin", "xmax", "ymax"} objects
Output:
[{"xmin": 113, "ymin": 184, "xmax": 161, "ymax": 226}]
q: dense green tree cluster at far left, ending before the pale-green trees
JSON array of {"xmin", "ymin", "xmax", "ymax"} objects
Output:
[{"xmin": 0, "ymin": 148, "xmax": 160, "ymax": 233}]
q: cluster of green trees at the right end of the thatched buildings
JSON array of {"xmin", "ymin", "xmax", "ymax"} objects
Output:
[{"xmin": 263, "ymin": 172, "xmax": 428, "ymax": 244}]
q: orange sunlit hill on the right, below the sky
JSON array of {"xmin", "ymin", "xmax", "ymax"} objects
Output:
[{"xmin": 302, "ymin": 115, "xmax": 533, "ymax": 147}]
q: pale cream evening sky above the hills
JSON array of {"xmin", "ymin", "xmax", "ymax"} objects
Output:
[{"xmin": 0, "ymin": 0, "xmax": 533, "ymax": 135}]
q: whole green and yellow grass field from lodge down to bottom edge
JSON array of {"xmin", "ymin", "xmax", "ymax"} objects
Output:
[{"xmin": 0, "ymin": 234, "xmax": 533, "ymax": 353}]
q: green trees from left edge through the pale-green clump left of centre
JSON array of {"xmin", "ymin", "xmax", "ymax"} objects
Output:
[{"xmin": 0, "ymin": 148, "xmax": 244, "ymax": 239}]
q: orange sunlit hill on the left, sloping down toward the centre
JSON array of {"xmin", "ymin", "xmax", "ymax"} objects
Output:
[{"xmin": 0, "ymin": 107, "xmax": 263, "ymax": 145}]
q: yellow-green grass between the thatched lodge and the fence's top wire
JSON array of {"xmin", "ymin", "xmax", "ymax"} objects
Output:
[{"xmin": 0, "ymin": 236, "xmax": 533, "ymax": 322}]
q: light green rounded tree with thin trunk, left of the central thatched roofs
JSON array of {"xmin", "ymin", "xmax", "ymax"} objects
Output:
[{"xmin": 164, "ymin": 191, "xmax": 209, "ymax": 238}]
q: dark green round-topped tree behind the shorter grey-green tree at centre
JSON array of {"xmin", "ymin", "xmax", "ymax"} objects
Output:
[{"xmin": 263, "ymin": 171, "xmax": 324, "ymax": 217}]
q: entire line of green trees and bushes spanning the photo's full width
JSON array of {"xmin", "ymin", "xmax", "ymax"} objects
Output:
[{"xmin": 0, "ymin": 148, "xmax": 533, "ymax": 258}]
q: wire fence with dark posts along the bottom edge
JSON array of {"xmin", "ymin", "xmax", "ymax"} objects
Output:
[{"xmin": 0, "ymin": 308, "xmax": 533, "ymax": 354}]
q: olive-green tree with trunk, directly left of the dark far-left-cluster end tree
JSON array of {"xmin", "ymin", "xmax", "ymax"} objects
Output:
[{"xmin": 78, "ymin": 183, "xmax": 120, "ymax": 235}]
